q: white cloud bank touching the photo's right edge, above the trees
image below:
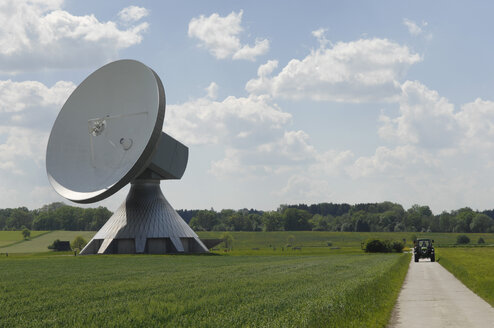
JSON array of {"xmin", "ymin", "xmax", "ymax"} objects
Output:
[{"xmin": 378, "ymin": 81, "xmax": 494, "ymax": 153}]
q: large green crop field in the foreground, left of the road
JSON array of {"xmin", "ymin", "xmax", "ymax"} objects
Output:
[{"xmin": 0, "ymin": 253, "xmax": 410, "ymax": 327}]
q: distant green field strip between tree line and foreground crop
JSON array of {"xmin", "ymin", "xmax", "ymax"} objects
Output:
[{"xmin": 0, "ymin": 231, "xmax": 494, "ymax": 255}]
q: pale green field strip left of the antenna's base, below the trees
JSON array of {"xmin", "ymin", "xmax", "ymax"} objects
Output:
[{"xmin": 0, "ymin": 231, "xmax": 95, "ymax": 254}]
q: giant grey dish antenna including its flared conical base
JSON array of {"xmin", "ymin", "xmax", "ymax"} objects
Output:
[{"xmin": 46, "ymin": 60, "xmax": 207, "ymax": 254}]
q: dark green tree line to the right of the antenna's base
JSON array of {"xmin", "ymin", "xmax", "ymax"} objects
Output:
[{"xmin": 183, "ymin": 202, "xmax": 494, "ymax": 233}]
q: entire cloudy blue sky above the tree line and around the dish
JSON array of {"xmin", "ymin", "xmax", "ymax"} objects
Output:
[{"xmin": 0, "ymin": 0, "xmax": 494, "ymax": 213}]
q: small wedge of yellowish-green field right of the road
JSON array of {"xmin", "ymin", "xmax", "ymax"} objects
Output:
[{"xmin": 437, "ymin": 247, "xmax": 494, "ymax": 306}]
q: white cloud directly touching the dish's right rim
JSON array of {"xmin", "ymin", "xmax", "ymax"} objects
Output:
[{"xmin": 165, "ymin": 91, "xmax": 291, "ymax": 145}]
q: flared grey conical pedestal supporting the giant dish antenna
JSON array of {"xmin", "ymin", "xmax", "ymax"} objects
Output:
[{"xmin": 80, "ymin": 180, "xmax": 208, "ymax": 255}]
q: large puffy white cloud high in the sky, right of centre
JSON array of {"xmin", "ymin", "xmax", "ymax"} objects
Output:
[{"xmin": 246, "ymin": 30, "xmax": 421, "ymax": 103}]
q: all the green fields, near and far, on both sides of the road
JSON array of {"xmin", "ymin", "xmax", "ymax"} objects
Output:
[{"xmin": 0, "ymin": 231, "xmax": 494, "ymax": 327}]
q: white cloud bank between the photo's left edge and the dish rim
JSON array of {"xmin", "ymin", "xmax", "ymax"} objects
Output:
[{"xmin": 0, "ymin": 80, "xmax": 75, "ymax": 207}]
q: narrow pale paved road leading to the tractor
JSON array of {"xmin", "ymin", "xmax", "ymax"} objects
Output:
[{"xmin": 388, "ymin": 259, "xmax": 494, "ymax": 328}]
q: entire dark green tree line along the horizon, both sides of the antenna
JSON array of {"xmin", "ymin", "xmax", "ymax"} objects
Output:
[{"xmin": 0, "ymin": 202, "xmax": 494, "ymax": 233}]
